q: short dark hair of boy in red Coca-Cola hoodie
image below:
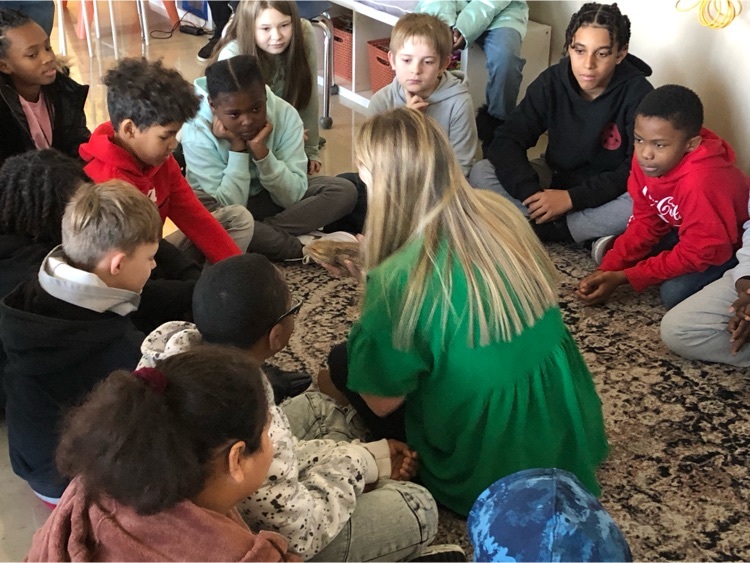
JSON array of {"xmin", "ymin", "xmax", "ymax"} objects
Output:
[{"xmin": 636, "ymin": 84, "xmax": 703, "ymax": 138}]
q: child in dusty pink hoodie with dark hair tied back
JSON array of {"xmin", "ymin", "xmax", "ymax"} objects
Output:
[{"xmin": 26, "ymin": 347, "xmax": 299, "ymax": 561}]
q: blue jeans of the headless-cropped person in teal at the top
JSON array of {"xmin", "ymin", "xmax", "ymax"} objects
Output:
[{"xmin": 476, "ymin": 27, "xmax": 526, "ymax": 120}]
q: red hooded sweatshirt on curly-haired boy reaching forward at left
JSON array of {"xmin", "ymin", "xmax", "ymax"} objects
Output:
[{"xmin": 78, "ymin": 121, "xmax": 242, "ymax": 263}]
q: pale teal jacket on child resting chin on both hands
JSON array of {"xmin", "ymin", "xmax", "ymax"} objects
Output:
[{"xmin": 182, "ymin": 77, "xmax": 307, "ymax": 209}]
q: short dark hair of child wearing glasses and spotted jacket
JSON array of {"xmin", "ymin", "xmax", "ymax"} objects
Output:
[{"xmin": 193, "ymin": 254, "xmax": 289, "ymax": 349}]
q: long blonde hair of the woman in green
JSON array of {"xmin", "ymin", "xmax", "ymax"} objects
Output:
[{"xmin": 355, "ymin": 108, "xmax": 557, "ymax": 349}]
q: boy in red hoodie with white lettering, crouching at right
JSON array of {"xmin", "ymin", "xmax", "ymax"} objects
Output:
[{"xmin": 576, "ymin": 84, "xmax": 748, "ymax": 309}]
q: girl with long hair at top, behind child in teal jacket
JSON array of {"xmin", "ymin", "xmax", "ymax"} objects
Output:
[{"xmin": 211, "ymin": 0, "xmax": 320, "ymax": 174}]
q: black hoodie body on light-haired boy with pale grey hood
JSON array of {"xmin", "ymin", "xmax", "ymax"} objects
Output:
[{"xmin": 0, "ymin": 279, "xmax": 144, "ymax": 497}]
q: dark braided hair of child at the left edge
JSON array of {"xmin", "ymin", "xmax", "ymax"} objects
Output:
[{"xmin": 0, "ymin": 149, "xmax": 90, "ymax": 245}]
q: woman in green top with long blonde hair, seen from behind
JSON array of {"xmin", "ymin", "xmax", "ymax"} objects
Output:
[{"xmin": 329, "ymin": 108, "xmax": 608, "ymax": 514}]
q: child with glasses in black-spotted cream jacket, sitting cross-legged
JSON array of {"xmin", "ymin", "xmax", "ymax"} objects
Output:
[{"xmin": 140, "ymin": 254, "xmax": 450, "ymax": 561}]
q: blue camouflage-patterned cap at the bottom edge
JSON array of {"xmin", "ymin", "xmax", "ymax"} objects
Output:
[{"xmin": 467, "ymin": 469, "xmax": 633, "ymax": 561}]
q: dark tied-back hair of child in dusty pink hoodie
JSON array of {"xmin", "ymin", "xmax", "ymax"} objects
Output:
[{"xmin": 57, "ymin": 346, "xmax": 268, "ymax": 515}]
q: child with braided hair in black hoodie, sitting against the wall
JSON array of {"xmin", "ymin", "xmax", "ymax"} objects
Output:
[{"xmin": 469, "ymin": 2, "xmax": 652, "ymax": 242}]
